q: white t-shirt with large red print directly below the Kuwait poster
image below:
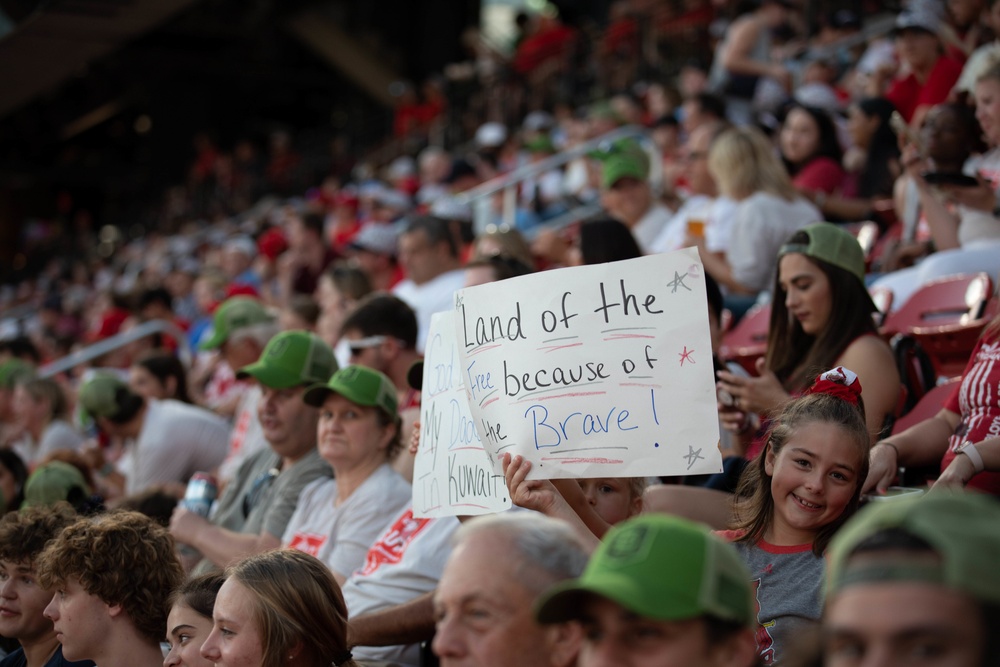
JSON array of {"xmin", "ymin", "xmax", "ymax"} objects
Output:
[{"xmin": 343, "ymin": 505, "xmax": 459, "ymax": 667}]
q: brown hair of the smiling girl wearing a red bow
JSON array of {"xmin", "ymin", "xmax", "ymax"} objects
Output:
[{"xmin": 731, "ymin": 394, "xmax": 871, "ymax": 556}]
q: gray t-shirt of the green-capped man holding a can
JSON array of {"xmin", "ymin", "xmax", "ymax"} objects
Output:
[{"xmin": 194, "ymin": 447, "xmax": 333, "ymax": 575}]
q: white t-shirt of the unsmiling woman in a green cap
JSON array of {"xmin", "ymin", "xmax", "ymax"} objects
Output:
[{"xmin": 281, "ymin": 463, "xmax": 413, "ymax": 577}]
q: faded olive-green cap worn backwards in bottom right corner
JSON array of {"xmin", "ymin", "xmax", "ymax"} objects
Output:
[{"xmin": 826, "ymin": 491, "xmax": 1000, "ymax": 605}]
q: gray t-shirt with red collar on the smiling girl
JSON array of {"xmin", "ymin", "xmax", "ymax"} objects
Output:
[{"xmin": 722, "ymin": 531, "xmax": 824, "ymax": 665}]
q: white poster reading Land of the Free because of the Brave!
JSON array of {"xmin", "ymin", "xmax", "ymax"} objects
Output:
[{"xmin": 455, "ymin": 248, "xmax": 722, "ymax": 479}]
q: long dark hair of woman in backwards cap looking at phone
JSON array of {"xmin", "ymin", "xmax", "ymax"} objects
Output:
[{"xmin": 765, "ymin": 231, "xmax": 877, "ymax": 392}]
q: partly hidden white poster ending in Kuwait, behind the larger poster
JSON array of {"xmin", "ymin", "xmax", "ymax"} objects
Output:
[{"xmin": 413, "ymin": 311, "xmax": 510, "ymax": 517}]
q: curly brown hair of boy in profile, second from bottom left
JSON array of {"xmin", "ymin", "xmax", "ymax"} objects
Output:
[{"xmin": 35, "ymin": 510, "xmax": 184, "ymax": 642}]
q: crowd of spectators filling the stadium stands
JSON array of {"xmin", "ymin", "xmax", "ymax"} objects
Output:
[{"xmin": 0, "ymin": 0, "xmax": 1000, "ymax": 667}]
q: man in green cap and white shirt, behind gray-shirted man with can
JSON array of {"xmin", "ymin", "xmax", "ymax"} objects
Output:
[{"xmin": 200, "ymin": 296, "xmax": 278, "ymax": 483}]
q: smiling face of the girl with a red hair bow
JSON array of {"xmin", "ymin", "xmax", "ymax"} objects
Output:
[{"xmin": 764, "ymin": 421, "xmax": 861, "ymax": 546}]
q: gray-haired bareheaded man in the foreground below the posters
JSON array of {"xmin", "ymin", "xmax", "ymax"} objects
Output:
[{"xmin": 433, "ymin": 512, "xmax": 587, "ymax": 667}]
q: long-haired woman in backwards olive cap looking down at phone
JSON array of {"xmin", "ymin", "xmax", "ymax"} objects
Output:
[{"xmin": 718, "ymin": 222, "xmax": 900, "ymax": 458}]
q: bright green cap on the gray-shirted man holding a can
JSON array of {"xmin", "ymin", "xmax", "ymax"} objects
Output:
[{"xmin": 236, "ymin": 331, "xmax": 337, "ymax": 389}]
